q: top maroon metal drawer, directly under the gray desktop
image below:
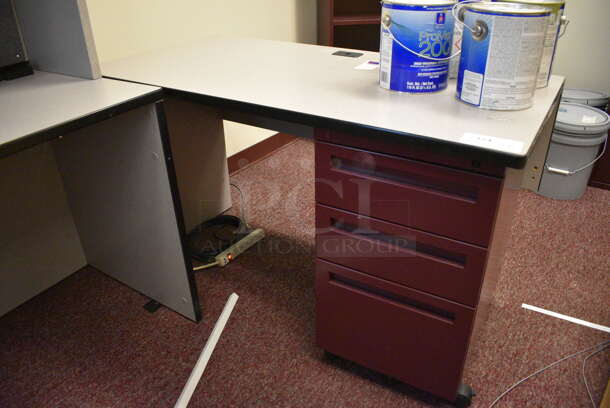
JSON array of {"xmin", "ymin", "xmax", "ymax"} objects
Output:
[{"xmin": 316, "ymin": 142, "xmax": 502, "ymax": 247}]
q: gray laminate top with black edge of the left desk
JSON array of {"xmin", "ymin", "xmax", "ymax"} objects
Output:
[{"xmin": 0, "ymin": 71, "xmax": 161, "ymax": 156}]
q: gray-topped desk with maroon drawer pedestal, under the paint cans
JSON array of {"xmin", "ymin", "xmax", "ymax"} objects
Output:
[{"xmin": 2, "ymin": 38, "xmax": 563, "ymax": 400}]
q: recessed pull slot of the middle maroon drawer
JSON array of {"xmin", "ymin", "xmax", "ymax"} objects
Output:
[{"xmin": 330, "ymin": 218, "xmax": 466, "ymax": 269}]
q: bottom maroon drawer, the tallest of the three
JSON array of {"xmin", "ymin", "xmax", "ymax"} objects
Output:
[{"xmin": 316, "ymin": 260, "xmax": 475, "ymax": 401}]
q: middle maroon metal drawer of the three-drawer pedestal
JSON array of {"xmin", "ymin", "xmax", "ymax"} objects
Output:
[{"xmin": 316, "ymin": 204, "xmax": 487, "ymax": 306}]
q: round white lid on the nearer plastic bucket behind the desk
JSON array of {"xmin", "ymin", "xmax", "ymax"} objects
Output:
[{"xmin": 555, "ymin": 102, "xmax": 610, "ymax": 135}]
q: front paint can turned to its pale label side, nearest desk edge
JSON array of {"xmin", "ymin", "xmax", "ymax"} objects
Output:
[{"xmin": 456, "ymin": 2, "xmax": 551, "ymax": 110}]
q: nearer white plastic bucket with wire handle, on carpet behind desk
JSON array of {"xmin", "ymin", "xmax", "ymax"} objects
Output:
[{"xmin": 538, "ymin": 103, "xmax": 610, "ymax": 200}]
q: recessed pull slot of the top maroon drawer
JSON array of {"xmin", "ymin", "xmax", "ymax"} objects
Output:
[{"xmin": 330, "ymin": 156, "xmax": 478, "ymax": 204}]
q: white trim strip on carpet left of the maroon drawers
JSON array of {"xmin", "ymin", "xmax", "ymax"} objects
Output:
[{"xmin": 174, "ymin": 293, "xmax": 239, "ymax": 408}]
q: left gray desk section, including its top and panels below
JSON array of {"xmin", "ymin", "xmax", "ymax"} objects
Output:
[{"xmin": 0, "ymin": 72, "xmax": 201, "ymax": 320}]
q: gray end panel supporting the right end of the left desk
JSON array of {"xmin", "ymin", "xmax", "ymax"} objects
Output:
[{"xmin": 54, "ymin": 100, "xmax": 201, "ymax": 321}]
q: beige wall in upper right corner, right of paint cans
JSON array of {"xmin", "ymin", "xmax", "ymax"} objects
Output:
[{"xmin": 553, "ymin": 0, "xmax": 610, "ymax": 93}]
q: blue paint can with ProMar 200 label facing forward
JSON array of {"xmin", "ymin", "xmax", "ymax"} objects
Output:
[{"xmin": 379, "ymin": 0, "xmax": 455, "ymax": 93}]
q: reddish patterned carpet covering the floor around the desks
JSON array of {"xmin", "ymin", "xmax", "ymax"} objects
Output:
[{"xmin": 0, "ymin": 140, "xmax": 610, "ymax": 408}]
